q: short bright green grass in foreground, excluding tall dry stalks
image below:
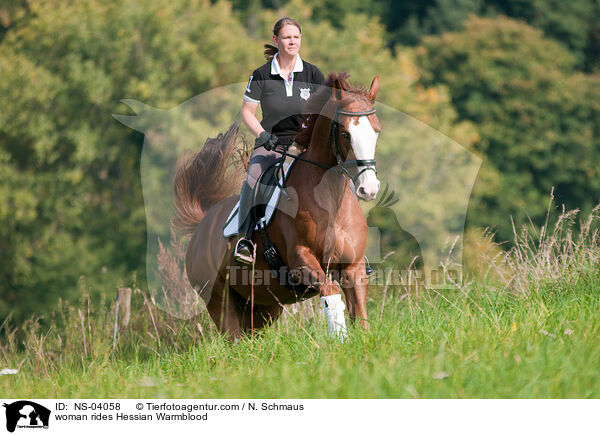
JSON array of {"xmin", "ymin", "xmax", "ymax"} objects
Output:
[{"xmin": 0, "ymin": 273, "xmax": 600, "ymax": 398}]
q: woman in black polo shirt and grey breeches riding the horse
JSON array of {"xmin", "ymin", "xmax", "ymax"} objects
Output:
[{"xmin": 234, "ymin": 17, "xmax": 325, "ymax": 264}]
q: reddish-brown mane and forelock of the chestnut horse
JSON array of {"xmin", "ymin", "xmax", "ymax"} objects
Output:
[{"xmin": 296, "ymin": 72, "xmax": 369, "ymax": 147}]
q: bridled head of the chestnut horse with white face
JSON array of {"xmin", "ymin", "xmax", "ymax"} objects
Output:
[{"xmin": 328, "ymin": 75, "xmax": 381, "ymax": 201}]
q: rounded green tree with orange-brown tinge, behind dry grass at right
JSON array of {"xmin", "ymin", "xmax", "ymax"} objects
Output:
[{"xmin": 419, "ymin": 16, "xmax": 600, "ymax": 240}]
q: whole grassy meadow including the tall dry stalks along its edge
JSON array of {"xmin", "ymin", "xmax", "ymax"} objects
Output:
[{"xmin": 0, "ymin": 208, "xmax": 600, "ymax": 398}]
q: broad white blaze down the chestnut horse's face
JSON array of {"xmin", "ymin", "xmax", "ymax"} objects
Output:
[{"xmin": 348, "ymin": 116, "xmax": 380, "ymax": 201}]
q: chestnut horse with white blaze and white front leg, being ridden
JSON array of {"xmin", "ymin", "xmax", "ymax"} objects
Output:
[{"xmin": 173, "ymin": 73, "xmax": 380, "ymax": 340}]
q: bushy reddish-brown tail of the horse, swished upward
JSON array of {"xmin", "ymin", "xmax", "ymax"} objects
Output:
[{"xmin": 172, "ymin": 122, "xmax": 243, "ymax": 234}]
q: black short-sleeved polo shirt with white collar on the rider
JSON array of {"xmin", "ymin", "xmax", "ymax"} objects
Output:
[{"xmin": 244, "ymin": 54, "xmax": 325, "ymax": 145}]
